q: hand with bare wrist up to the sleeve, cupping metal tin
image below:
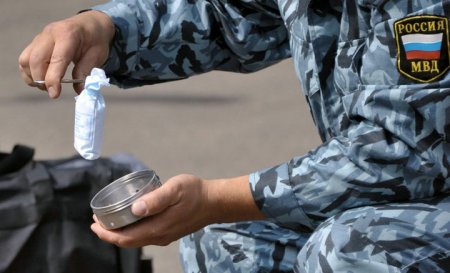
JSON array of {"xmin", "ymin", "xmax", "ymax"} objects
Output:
[{"xmin": 91, "ymin": 175, "xmax": 264, "ymax": 247}]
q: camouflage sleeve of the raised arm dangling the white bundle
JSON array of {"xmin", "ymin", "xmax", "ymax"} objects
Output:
[{"xmin": 93, "ymin": 0, "xmax": 290, "ymax": 87}]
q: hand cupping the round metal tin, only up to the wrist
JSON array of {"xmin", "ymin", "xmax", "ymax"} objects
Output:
[{"xmin": 91, "ymin": 175, "xmax": 210, "ymax": 247}]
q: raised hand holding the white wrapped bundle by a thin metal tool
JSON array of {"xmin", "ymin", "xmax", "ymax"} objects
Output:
[{"xmin": 19, "ymin": 11, "xmax": 115, "ymax": 98}]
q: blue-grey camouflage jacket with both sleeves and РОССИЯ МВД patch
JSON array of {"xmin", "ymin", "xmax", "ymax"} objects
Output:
[{"xmin": 95, "ymin": 0, "xmax": 450, "ymax": 231}]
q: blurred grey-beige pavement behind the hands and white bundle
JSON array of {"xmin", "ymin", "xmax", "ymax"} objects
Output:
[{"xmin": 0, "ymin": 0, "xmax": 320, "ymax": 273}]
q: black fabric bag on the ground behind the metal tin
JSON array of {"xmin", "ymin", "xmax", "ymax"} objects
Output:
[{"xmin": 0, "ymin": 145, "xmax": 151, "ymax": 273}]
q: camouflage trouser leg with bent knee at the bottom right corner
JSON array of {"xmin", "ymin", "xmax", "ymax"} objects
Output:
[{"xmin": 296, "ymin": 196, "xmax": 450, "ymax": 273}]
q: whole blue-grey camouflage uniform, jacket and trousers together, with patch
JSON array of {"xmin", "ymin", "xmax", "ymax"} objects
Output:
[{"xmin": 95, "ymin": 0, "xmax": 450, "ymax": 273}]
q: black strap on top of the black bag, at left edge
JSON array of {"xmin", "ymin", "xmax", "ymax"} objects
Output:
[{"xmin": 0, "ymin": 144, "xmax": 34, "ymax": 175}]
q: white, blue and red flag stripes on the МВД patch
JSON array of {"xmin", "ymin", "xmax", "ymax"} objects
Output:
[{"xmin": 401, "ymin": 33, "xmax": 442, "ymax": 60}]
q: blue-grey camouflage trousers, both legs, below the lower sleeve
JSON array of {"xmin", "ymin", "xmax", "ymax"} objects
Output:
[{"xmin": 180, "ymin": 193, "xmax": 450, "ymax": 273}]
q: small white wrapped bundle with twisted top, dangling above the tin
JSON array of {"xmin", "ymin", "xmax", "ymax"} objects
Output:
[{"xmin": 74, "ymin": 68, "xmax": 109, "ymax": 160}]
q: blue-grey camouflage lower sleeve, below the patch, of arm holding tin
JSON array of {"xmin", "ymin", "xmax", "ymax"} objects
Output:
[{"xmin": 250, "ymin": 85, "xmax": 450, "ymax": 230}]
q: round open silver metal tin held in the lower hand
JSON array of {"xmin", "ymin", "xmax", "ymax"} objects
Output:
[{"xmin": 91, "ymin": 170, "xmax": 161, "ymax": 229}]
